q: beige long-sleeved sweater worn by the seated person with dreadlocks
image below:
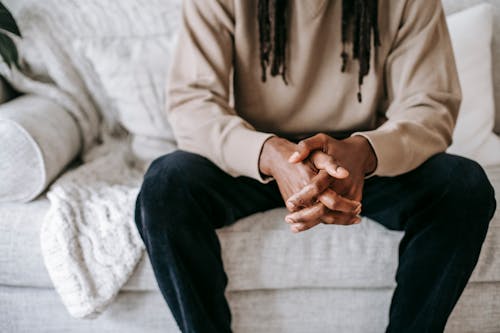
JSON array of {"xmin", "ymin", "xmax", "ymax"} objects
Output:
[{"xmin": 167, "ymin": 0, "xmax": 461, "ymax": 181}]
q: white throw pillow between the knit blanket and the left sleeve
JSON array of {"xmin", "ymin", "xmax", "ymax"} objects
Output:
[{"xmin": 74, "ymin": 34, "xmax": 175, "ymax": 160}]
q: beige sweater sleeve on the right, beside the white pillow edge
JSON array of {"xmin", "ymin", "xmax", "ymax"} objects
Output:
[{"xmin": 353, "ymin": 0, "xmax": 461, "ymax": 176}]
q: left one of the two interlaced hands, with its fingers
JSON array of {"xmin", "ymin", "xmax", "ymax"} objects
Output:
[{"xmin": 259, "ymin": 137, "xmax": 359, "ymax": 232}]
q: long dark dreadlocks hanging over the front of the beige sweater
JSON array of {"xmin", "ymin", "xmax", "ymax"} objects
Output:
[{"xmin": 258, "ymin": 0, "xmax": 380, "ymax": 103}]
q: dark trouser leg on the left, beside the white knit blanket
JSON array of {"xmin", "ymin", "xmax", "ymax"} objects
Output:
[{"xmin": 135, "ymin": 151, "xmax": 283, "ymax": 332}]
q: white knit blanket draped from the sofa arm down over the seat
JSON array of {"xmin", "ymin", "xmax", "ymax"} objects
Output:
[{"xmin": 0, "ymin": 4, "xmax": 149, "ymax": 318}]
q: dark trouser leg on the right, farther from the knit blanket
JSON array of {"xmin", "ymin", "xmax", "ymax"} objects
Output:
[{"xmin": 362, "ymin": 153, "xmax": 496, "ymax": 333}]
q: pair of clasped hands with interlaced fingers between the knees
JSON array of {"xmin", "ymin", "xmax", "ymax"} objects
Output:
[{"xmin": 259, "ymin": 134, "xmax": 377, "ymax": 232}]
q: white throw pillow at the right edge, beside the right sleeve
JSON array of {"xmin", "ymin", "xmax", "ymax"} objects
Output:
[{"xmin": 448, "ymin": 4, "xmax": 500, "ymax": 165}]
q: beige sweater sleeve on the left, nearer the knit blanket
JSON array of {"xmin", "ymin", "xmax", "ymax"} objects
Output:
[{"xmin": 167, "ymin": 0, "xmax": 272, "ymax": 182}]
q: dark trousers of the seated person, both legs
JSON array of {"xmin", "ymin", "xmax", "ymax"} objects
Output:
[{"xmin": 135, "ymin": 151, "xmax": 496, "ymax": 333}]
